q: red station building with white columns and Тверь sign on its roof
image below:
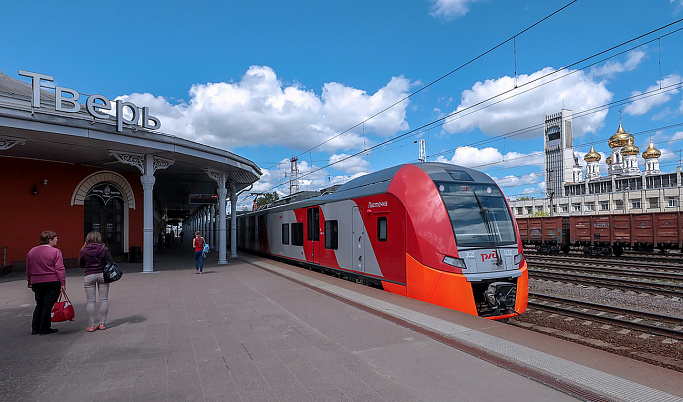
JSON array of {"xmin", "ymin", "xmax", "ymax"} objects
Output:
[{"xmin": 0, "ymin": 70, "xmax": 261, "ymax": 272}]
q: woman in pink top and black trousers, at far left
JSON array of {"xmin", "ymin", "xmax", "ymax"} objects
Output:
[{"xmin": 26, "ymin": 230, "xmax": 66, "ymax": 335}]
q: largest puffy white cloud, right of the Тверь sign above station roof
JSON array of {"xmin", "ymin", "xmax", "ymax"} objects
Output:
[{"xmin": 118, "ymin": 66, "xmax": 411, "ymax": 150}]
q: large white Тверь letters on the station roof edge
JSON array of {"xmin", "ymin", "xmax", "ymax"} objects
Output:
[{"xmin": 19, "ymin": 70, "xmax": 161, "ymax": 131}]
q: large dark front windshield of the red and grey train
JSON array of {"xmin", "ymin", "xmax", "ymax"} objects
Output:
[{"xmin": 434, "ymin": 182, "xmax": 517, "ymax": 248}]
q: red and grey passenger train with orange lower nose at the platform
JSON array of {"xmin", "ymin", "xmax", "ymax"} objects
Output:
[{"xmin": 237, "ymin": 163, "xmax": 528, "ymax": 319}]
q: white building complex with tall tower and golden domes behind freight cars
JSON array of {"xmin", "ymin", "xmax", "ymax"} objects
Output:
[{"xmin": 510, "ymin": 110, "xmax": 683, "ymax": 218}]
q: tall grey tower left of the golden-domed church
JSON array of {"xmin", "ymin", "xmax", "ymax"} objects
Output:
[{"xmin": 543, "ymin": 109, "xmax": 574, "ymax": 197}]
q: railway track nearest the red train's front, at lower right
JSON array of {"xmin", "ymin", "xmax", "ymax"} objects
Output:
[{"xmin": 529, "ymin": 293, "xmax": 683, "ymax": 341}]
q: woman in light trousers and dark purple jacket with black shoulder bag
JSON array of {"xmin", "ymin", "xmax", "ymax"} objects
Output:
[{"xmin": 78, "ymin": 232, "xmax": 111, "ymax": 332}]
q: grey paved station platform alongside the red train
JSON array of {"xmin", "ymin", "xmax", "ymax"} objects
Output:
[{"xmin": 0, "ymin": 242, "xmax": 683, "ymax": 401}]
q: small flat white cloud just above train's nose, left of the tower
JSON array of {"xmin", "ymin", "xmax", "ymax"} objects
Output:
[{"xmin": 436, "ymin": 146, "xmax": 543, "ymax": 168}]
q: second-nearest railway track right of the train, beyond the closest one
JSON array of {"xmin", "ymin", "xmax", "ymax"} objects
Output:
[{"xmin": 529, "ymin": 269, "xmax": 683, "ymax": 297}]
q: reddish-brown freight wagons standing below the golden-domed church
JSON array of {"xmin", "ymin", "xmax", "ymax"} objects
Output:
[{"xmin": 517, "ymin": 212, "xmax": 683, "ymax": 256}]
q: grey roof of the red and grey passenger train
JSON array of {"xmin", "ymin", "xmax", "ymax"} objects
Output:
[{"xmin": 251, "ymin": 162, "xmax": 494, "ymax": 212}]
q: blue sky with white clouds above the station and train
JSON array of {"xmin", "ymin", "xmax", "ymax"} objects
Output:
[{"xmin": 0, "ymin": 0, "xmax": 683, "ymax": 207}]
